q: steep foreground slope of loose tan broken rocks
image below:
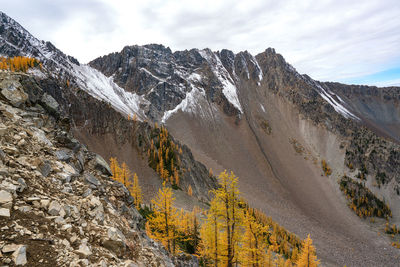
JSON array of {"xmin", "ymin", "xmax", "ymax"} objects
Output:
[{"xmin": 0, "ymin": 72, "xmax": 196, "ymax": 266}]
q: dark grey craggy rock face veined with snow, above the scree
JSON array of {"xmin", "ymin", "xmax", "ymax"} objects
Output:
[{"xmin": 89, "ymin": 44, "xmax": 240, "ymax": 121}]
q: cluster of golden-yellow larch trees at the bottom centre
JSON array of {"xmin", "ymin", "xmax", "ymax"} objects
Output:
[{"xmin": 146, "ymin": 171, "xmax": 319, "ymax": 267}]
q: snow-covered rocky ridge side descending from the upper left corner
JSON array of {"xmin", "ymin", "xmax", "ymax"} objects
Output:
[{"xmin": 0, "ymin": 11, "xmax": 147, "ymax": 119}]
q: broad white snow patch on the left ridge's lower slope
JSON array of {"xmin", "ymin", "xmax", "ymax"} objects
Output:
[{"xmin": 72, "ymin": 65, "xmax": 149, "ymax": 120}]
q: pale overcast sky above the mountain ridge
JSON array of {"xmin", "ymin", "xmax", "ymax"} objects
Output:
[{"xmin": 0, "ymin": 0, "xmax": 400, "ymax": 86}]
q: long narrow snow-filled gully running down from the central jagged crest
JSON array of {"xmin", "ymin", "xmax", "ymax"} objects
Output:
[{"xmin": 199, "ymin": 49, "xmax": 243, "ymax": 113}]
